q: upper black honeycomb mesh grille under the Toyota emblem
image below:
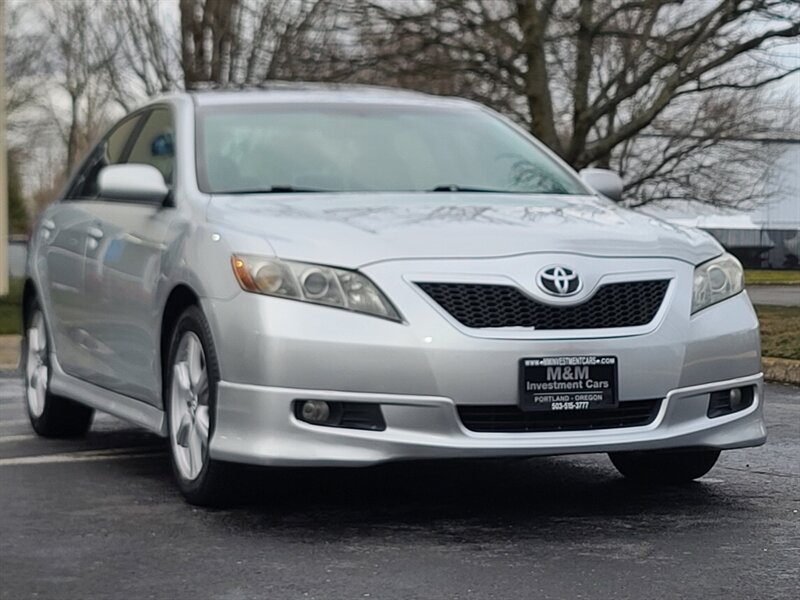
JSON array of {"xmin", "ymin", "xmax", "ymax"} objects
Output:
[{"xmin": 417, "ymin": 279, "xmax": 669, "ymax": 329}]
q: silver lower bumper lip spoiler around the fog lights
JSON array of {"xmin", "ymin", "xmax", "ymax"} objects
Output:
[{"xmin": 210, "ymin": 374, "xmax": 766, "ymax": 466}]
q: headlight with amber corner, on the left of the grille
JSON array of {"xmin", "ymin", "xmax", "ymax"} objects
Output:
[{"xmin": 231, "ymin": 254, "xmax": 401, "ymax": 321}]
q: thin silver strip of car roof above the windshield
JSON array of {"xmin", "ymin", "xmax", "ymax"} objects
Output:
[{"xmin": 188, "ymin": 82, "xmax": 476, "ymax": 108}]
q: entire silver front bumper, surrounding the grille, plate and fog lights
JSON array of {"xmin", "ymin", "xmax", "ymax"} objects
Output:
[{"xmin": 202, "ymin": 255, "xmax": 765, "ymax": 466}]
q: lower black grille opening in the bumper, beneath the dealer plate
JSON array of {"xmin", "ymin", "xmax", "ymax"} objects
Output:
[{"xmin": 458, "ymin": 399, "xmax": 661, "ymax": 433}]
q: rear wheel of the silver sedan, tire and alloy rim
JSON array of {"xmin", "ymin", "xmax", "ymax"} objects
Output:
[{"xmin": 22, "ymin": 300, "xmax": 94, "ymax": 438}]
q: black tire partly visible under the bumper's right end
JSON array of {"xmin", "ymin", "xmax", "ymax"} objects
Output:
[{"xmin": 608, "ymin": 450, "xmax": 720, "ymax": 483}]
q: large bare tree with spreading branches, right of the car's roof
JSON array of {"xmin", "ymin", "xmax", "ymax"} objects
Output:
[{"xmin": 360, "ymin": 0, "xmax": 800, "ymax": 202}]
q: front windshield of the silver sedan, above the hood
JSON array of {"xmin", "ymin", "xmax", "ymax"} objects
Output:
[{"xmin": 197, "ymin": 104, "xmax": 587, "ymax": 194}]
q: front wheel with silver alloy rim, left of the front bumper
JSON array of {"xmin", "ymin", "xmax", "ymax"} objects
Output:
[{"xmin": 164, "ymin": 306, "xmax": 232, "ymax": 506}]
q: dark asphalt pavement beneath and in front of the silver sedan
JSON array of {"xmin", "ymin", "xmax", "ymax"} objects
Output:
[{"xmin": 0, "ymin": 377, "xmax": 800, "ymax": 600}]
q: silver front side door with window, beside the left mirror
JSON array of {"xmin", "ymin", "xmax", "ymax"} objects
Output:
[{"xmin": 79, "ymin": 106, "xmax": 175, "ymax": 405}]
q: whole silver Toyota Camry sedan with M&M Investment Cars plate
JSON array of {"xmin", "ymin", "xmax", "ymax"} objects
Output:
[{"xmin": 23, "ymin": 86, "xmax": 766, "ymax": 504}]
